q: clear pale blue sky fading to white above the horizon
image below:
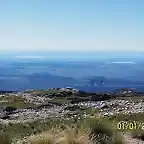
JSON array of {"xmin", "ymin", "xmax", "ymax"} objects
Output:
[{"xmin": 0, "ymin": 0, "xmax": 144, "ymax": 52}]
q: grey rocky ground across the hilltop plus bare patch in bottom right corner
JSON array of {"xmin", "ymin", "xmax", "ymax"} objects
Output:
[{"xmin": 0, "ymin": 88, "xmax": 144, "ymax": 144}]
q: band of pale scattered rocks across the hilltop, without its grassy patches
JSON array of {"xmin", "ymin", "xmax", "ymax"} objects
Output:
[{"xmin": 0, "ymin": 89, "xmax": 144, "ymax": 123}]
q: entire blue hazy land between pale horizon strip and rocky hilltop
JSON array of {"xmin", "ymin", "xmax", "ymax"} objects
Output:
[{"xmin": 0, "ymin": 54, "xmax": 144, "ymax": 91}]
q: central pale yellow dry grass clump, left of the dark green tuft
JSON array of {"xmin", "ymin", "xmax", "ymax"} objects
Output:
[{"xmin": 24, "ymin": 128, "xmax": 93, "ymax": 144}]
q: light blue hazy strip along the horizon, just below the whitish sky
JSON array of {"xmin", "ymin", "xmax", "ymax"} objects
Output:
[{"xmin": 0, "ymin": 51, "xmax": 144, "ymax": 60}]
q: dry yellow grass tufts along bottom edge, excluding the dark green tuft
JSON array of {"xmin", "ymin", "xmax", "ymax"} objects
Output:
[{"xmin": 0, "ymin": 127, "xmax": 127, "ymax": 144}]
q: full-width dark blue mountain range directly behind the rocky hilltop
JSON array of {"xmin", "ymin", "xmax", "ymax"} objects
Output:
[{"xmin": 0, "ymin": 73, "xmax": 144, "ymax": 92}]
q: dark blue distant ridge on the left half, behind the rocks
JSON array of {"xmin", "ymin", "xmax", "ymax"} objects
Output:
[{"xmin": 0, "ymin": 73, "xmax": 77, "ymax": 90}]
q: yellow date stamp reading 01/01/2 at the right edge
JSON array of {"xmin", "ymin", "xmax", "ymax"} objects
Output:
[{"xmin": 116, "ymin": 121, "xmax": 144, "ymax": 130}]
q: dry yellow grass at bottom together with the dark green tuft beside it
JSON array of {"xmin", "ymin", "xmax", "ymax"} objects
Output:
[{"xmin": 0, "ymin": 121, "xmax": 127, "ymax": 144}]
